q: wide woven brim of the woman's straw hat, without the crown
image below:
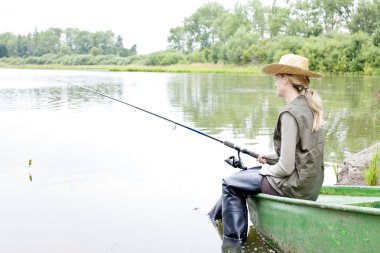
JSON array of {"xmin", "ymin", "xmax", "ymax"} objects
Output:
[{"xmin": 261, "ymin": 64, "xmax": 323, "ymax": 78}]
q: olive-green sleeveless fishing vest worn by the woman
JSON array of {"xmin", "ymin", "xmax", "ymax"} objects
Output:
[{"xmin": 273, "ymin": 95, "xmax": 324, "ymax": 200}]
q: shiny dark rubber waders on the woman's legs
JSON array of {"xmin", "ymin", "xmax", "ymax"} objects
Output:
[{"xmin": 209, "ymin": 166, "xmax": 263, "ymax": 241}]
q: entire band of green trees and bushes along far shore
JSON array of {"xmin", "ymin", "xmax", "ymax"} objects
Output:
[{"xmin": 0, "ymin": 0, "xmax": 380, "ymax": 74}]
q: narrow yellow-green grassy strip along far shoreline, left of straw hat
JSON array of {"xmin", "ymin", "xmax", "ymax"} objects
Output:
[{"xmin": 0, "ymin": 63, "xmax": 262, "ymax": 75}]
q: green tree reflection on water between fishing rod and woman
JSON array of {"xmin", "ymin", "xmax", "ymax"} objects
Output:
[{"xmin": 168, "ymin": 75, "xmax": 281, "ymax": 148}]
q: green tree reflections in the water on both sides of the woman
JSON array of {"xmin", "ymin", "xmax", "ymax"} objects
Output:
[{"xmin": 168, "ymin": 72, "xmax": 380, "ymax": 160}]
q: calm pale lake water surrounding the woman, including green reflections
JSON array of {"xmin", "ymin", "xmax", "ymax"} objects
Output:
[{"xmin": 0, "ymin": 69, "xmax": 380, "ymax": 253}]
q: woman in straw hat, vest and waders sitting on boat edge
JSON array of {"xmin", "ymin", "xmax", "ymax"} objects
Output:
[{"xmin": 209, "ymin": 54, "xmax": 324, "ymax": 245}]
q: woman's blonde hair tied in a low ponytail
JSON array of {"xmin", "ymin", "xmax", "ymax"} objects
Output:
[{"xmin": 288, "ymin": 75, "xmax": 324, "ymax": 131}]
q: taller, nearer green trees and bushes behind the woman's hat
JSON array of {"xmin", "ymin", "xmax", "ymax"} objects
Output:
[{"xmin": 168, "ymin": 0, "xmax": 380, "ymax": 73}]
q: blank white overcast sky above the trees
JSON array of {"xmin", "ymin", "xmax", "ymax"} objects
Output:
[{"xmin": 0, "ymin": 0, "xmax": 246, "ymax": 54}]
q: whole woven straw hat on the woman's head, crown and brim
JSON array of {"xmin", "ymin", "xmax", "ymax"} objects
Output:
[{"xmin": 262, "ymin": 54, "xmax": 322, "ymax": 78}]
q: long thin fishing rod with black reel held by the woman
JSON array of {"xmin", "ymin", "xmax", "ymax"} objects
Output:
[{"xmin": 50, "ymin": 78, "xmax": 277, "ymax": 169}]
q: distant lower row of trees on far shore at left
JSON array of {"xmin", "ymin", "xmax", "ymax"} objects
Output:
[{"xmin": 0, "ymin": 28, "xmax": 137, "ymax": 58}]
